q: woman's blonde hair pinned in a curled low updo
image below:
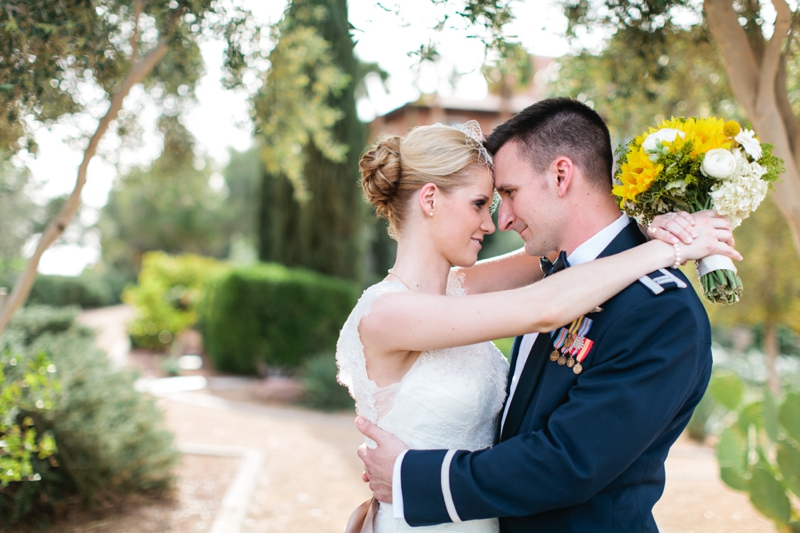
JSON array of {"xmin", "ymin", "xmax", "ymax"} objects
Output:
[{"xmin": 358, "ymin": 121, "xmax": 491, "ymax": 236}]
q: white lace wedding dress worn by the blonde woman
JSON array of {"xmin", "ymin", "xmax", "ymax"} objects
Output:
[{"xmin": 336, "ymin": 275, "xmax": 508, "ymax": 533}]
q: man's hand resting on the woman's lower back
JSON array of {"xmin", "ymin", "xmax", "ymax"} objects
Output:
[{"xmin": 356, "ymin": 417, "xmax": 408, "ymax": 503}]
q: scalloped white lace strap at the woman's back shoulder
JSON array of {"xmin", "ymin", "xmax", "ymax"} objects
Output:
[{"xmin": 336, "ymin": 281, "xmax": 408, "ymax": 423}]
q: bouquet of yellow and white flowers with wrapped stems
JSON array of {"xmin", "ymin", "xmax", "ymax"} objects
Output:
[{"xmin": 612, "ymin": 117, "xmax": 785, "ymax": 304}]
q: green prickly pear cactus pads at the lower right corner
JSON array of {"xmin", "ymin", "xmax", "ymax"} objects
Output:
[{"xmin": 710, "ymin": 372, "xmax": 800, "ymax": 533}]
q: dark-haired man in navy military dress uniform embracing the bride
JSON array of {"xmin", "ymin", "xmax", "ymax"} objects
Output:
[{"xmin": 358, "ymin": 98, "xmax": 711, "ymax": 533}]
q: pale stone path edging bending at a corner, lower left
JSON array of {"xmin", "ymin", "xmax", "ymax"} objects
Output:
[{"xmin": 178, "ymin": 444, "xmax": 264, "ymax": 533}]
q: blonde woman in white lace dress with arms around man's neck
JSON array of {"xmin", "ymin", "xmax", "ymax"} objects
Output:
[{"xmin": 336, "ymin": 121, "xmax": 739, "ymax": 533}]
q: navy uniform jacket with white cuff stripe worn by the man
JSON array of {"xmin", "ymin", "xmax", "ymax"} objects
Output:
[{"xmin": 401, "ymin": 223, "xmax": 711, "ymax": 533}]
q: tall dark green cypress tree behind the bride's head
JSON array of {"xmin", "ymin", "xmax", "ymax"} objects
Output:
[{"xmin": 259, "ymin": 0, "xmax": 365, "ymax": 280}]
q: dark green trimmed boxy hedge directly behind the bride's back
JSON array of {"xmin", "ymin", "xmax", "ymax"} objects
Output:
[{"xmin": 203, "ymin": 263, "xmax": 361, "ymax": 373}]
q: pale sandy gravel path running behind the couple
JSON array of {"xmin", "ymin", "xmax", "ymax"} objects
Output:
[{"xmin": 78, "ymin": 306, "xmax": 776, "ymax": 533}]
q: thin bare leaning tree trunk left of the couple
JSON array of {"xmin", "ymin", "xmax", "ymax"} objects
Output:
[{"xmin": 0, "ymin": 37, "xmax": 168, "ymax": 337}]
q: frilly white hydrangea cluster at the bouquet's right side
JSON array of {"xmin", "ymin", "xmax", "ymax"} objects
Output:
[{"xmin": 709, "ymin": 150, "xmax": 769, "ymax": 228}]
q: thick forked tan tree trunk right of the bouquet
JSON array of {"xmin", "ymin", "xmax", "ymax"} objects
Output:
[{"xmin": 704, "ymin": 0, "xmax": 800, "ymax": 255}]
